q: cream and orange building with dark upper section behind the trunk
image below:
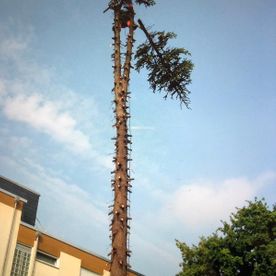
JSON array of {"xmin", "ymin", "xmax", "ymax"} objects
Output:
[{"xmin": 0, "ymin": 176, "xmax": 141, "ymax": 276}]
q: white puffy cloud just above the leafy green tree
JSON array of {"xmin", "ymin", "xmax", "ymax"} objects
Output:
[{"xmin": 163, "ymin": 173, "xmax": 276, "ymax": 229}]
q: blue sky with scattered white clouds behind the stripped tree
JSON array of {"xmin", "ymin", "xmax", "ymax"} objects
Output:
[{"xmin": 0, "ymin": 0, "xmax": 276, "ymax": 276}]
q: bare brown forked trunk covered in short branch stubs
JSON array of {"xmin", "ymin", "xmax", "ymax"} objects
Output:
[{"xmin": 111, "ymin": 1, "xmax": 134, "ymax": 276}]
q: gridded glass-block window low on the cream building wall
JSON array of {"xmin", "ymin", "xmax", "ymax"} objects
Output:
[{"xmin": 11, "ymin": 244, "xmax": 31, "ymax": 276}]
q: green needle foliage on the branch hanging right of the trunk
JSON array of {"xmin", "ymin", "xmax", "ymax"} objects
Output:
[{"xmin": 135, "ymin": 31, "xmax": 193, "ymax": 107}]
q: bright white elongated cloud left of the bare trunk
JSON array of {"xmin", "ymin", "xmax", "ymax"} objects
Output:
[{"xmin": 3, "ymin": 94, "xmax": 91, "ymax": 152}]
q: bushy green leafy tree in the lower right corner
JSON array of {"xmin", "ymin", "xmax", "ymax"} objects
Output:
[{"xmin": 176, "ymin": 199, "xmax": 276, "ymax": 276}]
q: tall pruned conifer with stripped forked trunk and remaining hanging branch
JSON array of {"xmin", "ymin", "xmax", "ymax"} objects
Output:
[{"xmin": 104, "ymin": 0, "xmax": 193, "ymax": 276}]
